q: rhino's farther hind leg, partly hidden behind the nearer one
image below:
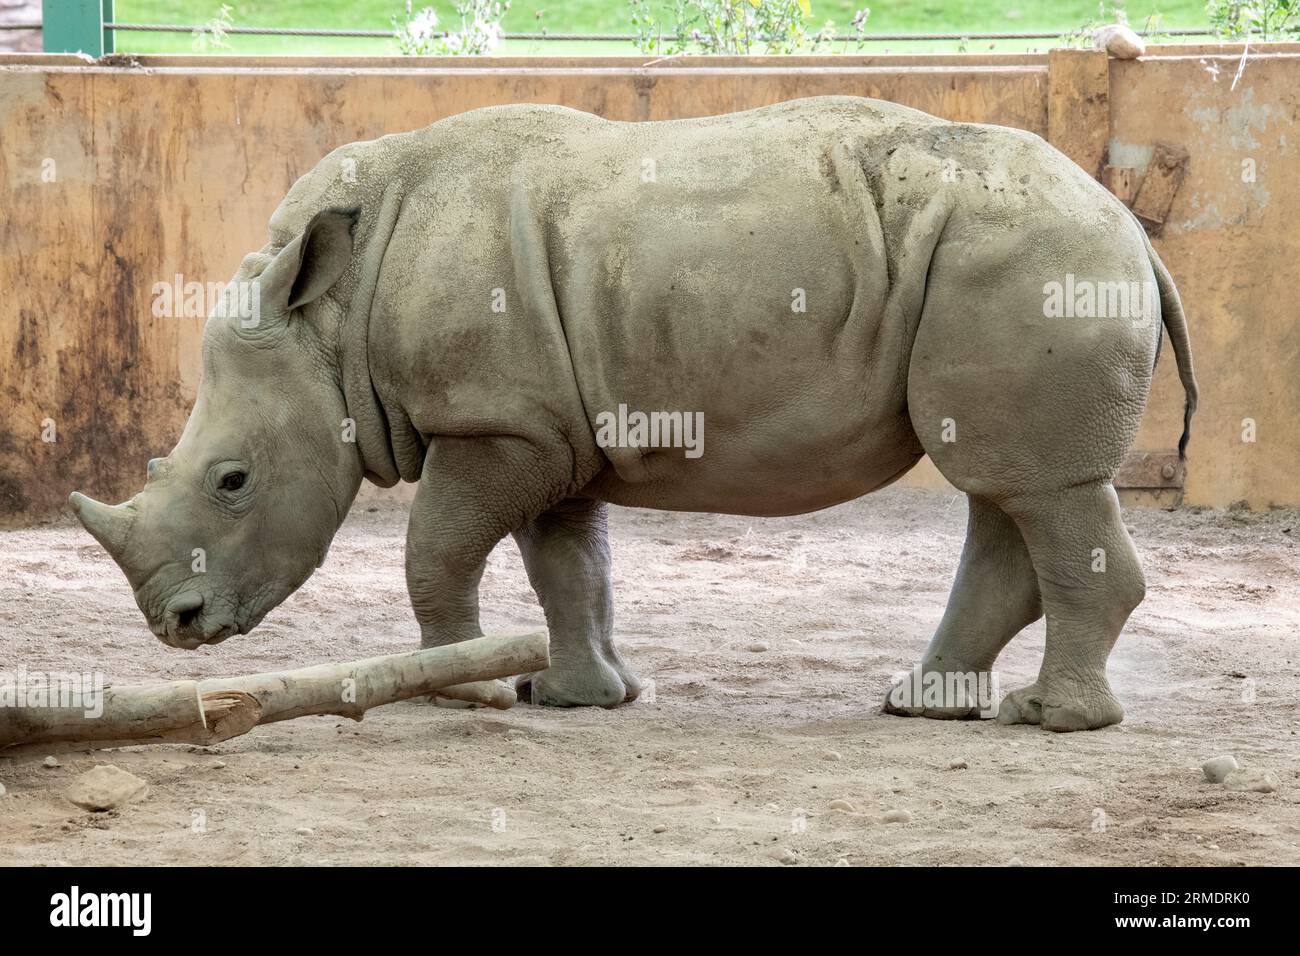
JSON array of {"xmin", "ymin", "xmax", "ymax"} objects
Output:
[{"xmin": 884, "ymin": 494, "xmax": 1043, "ymax": 719}]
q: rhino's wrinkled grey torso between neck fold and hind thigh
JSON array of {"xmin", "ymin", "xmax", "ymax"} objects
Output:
[{"xmin": 372, "ymin": 98, "xmax": 941, "ymax": 510}]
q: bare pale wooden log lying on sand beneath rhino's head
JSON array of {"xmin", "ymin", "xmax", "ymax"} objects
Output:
[{"xmin": 0, "ymin": 632, "xmax": 550, "ymax": 756}]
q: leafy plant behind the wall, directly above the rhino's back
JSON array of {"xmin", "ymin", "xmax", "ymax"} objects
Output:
[{"xmin": 628, "ymin": 0, "xmax": 871, "ymax": 56}]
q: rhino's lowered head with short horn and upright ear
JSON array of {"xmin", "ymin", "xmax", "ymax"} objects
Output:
[{"xmin": 70, "ymin": 209, "xmax": 363, "ymax": 649}]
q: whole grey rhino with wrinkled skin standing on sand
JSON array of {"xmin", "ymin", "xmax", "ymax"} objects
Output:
[{"xmin": 73, "ymin": 98, "xmax": 1196, "ymax": 730}]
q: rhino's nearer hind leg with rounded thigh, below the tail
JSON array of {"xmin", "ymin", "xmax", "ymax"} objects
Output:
[{"xmin": 907, "ymin": 217, "xmax": 1161, "ymax": 731}]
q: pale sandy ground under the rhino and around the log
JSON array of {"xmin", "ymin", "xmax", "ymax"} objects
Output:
[{"xmin": 0, "ymin": 489, "xmax": 1300, "ymax": 865}]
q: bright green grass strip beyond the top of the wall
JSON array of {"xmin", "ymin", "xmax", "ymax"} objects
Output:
[{"xmin": 114, "ymin": 0, "xmax": 1208, "ymax": 56}]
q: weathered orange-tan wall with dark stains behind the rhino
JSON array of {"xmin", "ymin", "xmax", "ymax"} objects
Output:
[{"xmin": 0, "ymin": 46, "xmax": 1300, "ymax": 522}]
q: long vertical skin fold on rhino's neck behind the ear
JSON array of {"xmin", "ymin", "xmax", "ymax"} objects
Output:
[{"xmin": 339, "ymin": 186, "xmax": 402, "ymax": 488}]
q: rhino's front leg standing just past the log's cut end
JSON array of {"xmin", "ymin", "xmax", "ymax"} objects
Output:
[{"xmin": 515, "ymin": 498, "xmax": 641, "ymax": 708}]
